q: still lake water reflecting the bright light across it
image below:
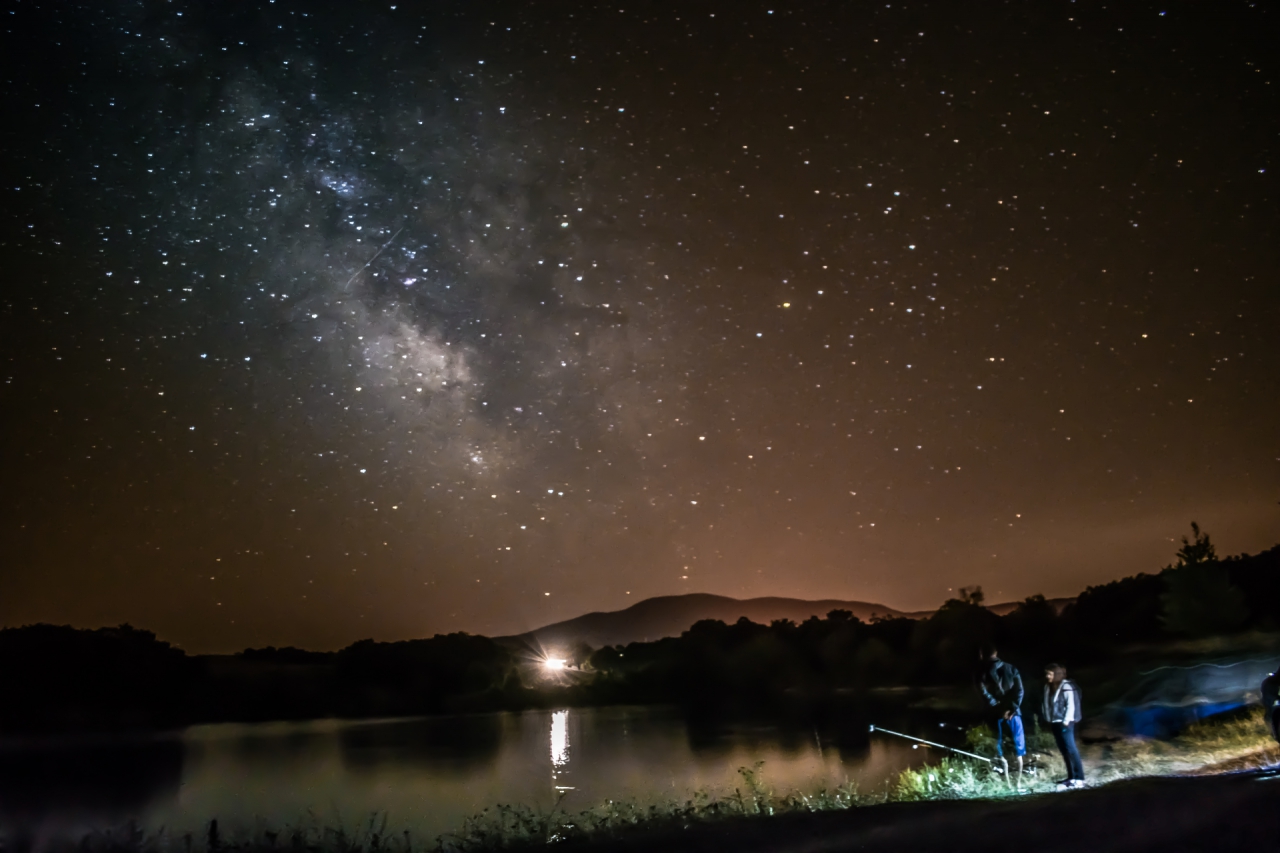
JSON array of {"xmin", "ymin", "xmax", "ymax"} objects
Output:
[{"xmin": 0, "ymin": 708, "xmax": 924, "ymax": 840}]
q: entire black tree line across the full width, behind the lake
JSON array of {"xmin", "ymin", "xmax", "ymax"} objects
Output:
[{"xmin": 0, "ymin": 524, "xmax": 1280, "ymax": 734}]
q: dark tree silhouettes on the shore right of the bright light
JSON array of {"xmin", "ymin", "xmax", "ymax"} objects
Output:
[{"xmin": 591, "ymin": 525, "xmax": 1280, "ymax": 708}]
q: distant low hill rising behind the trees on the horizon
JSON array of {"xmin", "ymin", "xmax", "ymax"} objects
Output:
[{"xmin": 497, "ymin": 593, "xmax": 906, "ymax": 653}]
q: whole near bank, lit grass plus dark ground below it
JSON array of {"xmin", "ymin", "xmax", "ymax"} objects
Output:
[{"xmin": 0, "ymin": 708, "xmax": 1280, "ymax": 853}]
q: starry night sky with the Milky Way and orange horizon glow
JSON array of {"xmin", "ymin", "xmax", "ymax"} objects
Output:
[{"xmin": 0, "ymin": 0, "xmax": 1280, "ymax": 651}]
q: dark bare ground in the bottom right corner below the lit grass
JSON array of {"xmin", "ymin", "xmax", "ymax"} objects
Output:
[{"xmin": 568, "ymin": 771, "xmax": 1280, "ymax": 853}]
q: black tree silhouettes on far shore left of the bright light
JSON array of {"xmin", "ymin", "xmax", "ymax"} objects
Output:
[{"xmin": 0, "ymin": 625, "xmax": 529, "ymax": 731}]
